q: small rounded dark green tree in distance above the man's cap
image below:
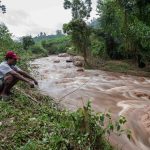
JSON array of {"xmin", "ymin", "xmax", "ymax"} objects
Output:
[{"xmin": 22, "ymin": 36, "xmax": 35, "ymax": 50}]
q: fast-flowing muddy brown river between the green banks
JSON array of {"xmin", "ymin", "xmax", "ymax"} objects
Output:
[{"xmin": 30, "ymin": 56, "xmax": 150, "ymax": 150}]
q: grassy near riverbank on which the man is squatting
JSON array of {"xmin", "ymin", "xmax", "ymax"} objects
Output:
[{"xmin": 0, "ymin": 52, "xmax": 118, "ymax": 150}]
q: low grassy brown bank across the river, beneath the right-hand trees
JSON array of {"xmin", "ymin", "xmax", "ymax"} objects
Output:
[{"xmin": 86, "ymin": 60, "xmax": 150, "ymax": 77}]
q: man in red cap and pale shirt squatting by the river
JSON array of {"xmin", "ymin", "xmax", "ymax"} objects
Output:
[{"xmin": 0, "ymin": 51, "xmax": 38, "ymax": 99}]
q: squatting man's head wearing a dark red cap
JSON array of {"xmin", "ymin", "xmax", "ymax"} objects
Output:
[{"xmin": 5, "ymin": 51, "xmax": 19, "ymax": 65}]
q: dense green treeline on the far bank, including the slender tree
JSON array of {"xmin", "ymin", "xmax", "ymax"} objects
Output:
[{"xmin": 64, "ymin": 0, "xmax": 150, "ymax": 67}]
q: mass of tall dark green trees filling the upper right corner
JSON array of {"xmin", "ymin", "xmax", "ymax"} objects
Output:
[{"xmin": 97, "ymin": 0, "xmax": 150, "ymax": 67}]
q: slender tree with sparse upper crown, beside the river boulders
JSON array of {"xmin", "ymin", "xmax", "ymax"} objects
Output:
[{"xmin": 63, "ymin": 0, "xmax": 92, "ymax": 62}]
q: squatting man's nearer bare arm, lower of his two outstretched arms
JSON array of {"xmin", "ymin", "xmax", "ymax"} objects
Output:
[{"xmin": 10, "ymin": 70, "xmax": 34, "ymax": 87}]
